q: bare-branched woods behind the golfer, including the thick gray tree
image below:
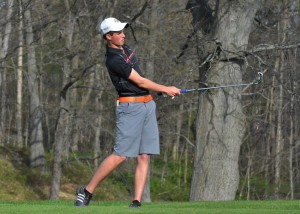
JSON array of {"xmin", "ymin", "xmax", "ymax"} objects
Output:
[{"xmin": 0, "ymin": 0, "xmax": 300, "ymax": 201}]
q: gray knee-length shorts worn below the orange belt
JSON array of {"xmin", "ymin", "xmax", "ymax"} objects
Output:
[{"xmin": 114, "ymin": 100, "xmax": 160, "ymax": 157}]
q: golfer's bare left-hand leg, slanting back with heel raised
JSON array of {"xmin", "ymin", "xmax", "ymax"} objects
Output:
[{"xmin": 85, "ymin": 154, "xmax": 127, "ymax": 193}]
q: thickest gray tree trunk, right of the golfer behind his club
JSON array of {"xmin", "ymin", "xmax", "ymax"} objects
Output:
[{"xmin": 190, "ymin": 0, "xmax": 259, "ymax": 201}]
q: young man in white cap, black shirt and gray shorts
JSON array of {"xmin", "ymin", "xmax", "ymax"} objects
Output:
[{"xmin": 74, "ymin": 18, "xmax": 180, "ymax": 208}]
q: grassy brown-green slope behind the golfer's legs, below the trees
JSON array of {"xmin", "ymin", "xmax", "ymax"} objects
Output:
[{"xmin": 0, "ymin": 147, "xmax": 191, "ymax": 201}]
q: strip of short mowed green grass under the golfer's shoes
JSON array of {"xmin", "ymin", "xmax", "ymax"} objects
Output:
[{"xmin": 0, "ymin": 201, "xmax": 300, "ymax": 214}]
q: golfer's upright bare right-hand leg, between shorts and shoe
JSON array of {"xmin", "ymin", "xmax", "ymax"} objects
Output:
[{"xmin": 133, "ymin": 154, "xmax": 149, "ymax": 202}]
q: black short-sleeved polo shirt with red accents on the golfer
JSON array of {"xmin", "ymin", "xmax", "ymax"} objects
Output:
[{"xmin": 105, "ymin": 45, "xmax": 149, "ymax": 97}]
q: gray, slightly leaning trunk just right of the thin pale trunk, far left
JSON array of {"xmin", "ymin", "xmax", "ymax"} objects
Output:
[{"xmin": 24, "ymin": 0, "xmax": 45, "ymax": 171}]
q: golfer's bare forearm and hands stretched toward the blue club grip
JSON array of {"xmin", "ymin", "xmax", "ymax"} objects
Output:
[{"xmin": 128, "ymin": 69, "xmax": 180, "ymax": 97}]
